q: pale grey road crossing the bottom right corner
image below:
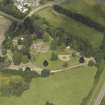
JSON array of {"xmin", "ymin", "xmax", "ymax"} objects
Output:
[{"xmin": 94, "ymin": 83, "xmax": 105, "ymax": 105}]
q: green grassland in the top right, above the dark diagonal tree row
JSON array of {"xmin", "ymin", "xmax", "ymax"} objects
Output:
[{"xmin": 62, "ymin": 0, "xmax": 105, "ymax": 26}]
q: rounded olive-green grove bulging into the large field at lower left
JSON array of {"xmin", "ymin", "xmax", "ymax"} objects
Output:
[{"xmin": 0, "ymin": 76, "xmax": 29, "ymax": 96}]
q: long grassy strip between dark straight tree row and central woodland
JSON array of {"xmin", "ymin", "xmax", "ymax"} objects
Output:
[{"xmin": 38, "ymin": 8, "xmax": 103, "ymax": 48}]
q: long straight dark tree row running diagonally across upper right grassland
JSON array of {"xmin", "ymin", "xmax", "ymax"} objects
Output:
[{"xmin": 53, "ymin": 5, "xmax": 105, "ymax": 32}]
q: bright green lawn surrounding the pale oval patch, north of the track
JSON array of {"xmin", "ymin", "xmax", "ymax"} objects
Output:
[{"xmin": 30, "ymin": 41, "xmax": 79, "ymax": 70}]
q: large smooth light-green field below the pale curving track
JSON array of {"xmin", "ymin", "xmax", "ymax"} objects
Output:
[{"xmin": 0, "ymin": 67, "xmax": 96, "ymax": 105}]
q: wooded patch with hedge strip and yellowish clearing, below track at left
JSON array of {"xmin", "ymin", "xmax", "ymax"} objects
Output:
[{"xmin": 0, "ymin": 67, "xmax": 39, "ymax": 96}]
